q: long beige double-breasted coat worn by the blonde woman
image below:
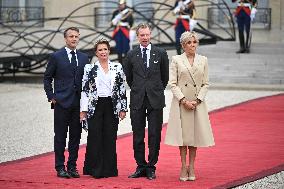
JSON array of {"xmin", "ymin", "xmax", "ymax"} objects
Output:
[{"xmin": 165, "ymin": 53, "xmax": 215, "ymax": 147}]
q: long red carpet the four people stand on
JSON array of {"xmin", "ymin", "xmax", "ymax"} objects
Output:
[{"xmin": 0, "ymin": 94, "xmax": 284, "ymax": 189}]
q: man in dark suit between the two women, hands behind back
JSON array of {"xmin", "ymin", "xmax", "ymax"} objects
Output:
[{"xmin": 123, "ymin": 23, "xmax": 169, "ymax": 180}]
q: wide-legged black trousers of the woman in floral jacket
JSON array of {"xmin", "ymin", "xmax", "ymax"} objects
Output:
[{"xmin": 83, "ymin": 97, "xmax": 118, "ymax": 178}]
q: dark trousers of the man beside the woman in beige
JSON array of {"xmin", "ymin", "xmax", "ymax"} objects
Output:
[{"xmin": 130, "ymin": 96, "xmax": 163, "ymax": 170}]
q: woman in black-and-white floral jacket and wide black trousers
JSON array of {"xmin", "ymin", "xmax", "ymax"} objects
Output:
[{"xmin": 80, "ymin": 39, "xmax": 127, "ymax": 178}]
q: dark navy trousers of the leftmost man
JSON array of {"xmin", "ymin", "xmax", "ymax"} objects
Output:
[{"xmin": 54, "ymin": 96, "xmax": 82, "ymax": 170}]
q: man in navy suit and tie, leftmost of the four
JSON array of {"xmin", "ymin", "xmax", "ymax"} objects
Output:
[{"xmin": 44, "ymin": 27, "xmax": 89, "ymax": 178}]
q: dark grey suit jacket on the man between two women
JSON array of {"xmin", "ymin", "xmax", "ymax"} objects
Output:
[{"xmin": 123, "ymin": 45, "xmax": 169, "ymax": 109}]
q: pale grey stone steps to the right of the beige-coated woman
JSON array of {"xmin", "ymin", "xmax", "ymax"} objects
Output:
[{"xmin": 198, "ymin": 42, "xmax": 284, "ymax": 86}]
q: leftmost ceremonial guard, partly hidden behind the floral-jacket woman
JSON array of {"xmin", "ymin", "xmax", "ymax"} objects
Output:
[{"xmin": 111, "ymin": 0, "xmax": 133, "ymax": 63}]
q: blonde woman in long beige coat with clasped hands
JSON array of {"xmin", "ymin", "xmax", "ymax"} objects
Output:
[{"xmin": 165, "ymin": 31, "xmax": 214, "ymax": 181}]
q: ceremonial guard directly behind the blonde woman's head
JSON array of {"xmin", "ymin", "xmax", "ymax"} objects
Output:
[{"xmin": 173, "ymin": 0, "xmax": 196, "ymax": 54}]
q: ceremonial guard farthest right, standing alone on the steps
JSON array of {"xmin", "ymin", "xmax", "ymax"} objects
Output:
[{"xmin": 232, "ymin": 0, "xmax": 257, "ymax": 53}]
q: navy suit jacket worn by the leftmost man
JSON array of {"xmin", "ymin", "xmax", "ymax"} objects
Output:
[{"xmin": 44, "ymin": 48, "xmax": 89, "ymax": 108}]
